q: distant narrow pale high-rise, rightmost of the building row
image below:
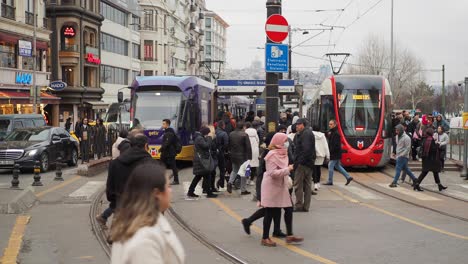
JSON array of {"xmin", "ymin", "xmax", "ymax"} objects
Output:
[{"xmin": 204, "ymin": 11, "xmax": 229, "ymax": 81}]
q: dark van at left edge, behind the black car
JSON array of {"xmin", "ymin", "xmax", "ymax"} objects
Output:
[{"xmin": 0, "ymin": 114, "xmax": 46, "ymax": 138}]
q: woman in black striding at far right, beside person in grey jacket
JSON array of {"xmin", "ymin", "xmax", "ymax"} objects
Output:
[{"xmin": 414, "ymin": 128, "xmax": 447, "ymax": 192}]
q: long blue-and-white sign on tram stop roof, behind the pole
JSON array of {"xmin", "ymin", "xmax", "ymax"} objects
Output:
[{"xmin": 217, "ymin": 80, "xmax": 295, "ymax": 94}]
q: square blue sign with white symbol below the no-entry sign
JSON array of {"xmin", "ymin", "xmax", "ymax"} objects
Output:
[{"xmin": 265, "ymin": 43, "xmax": 289, "ymax": 72}]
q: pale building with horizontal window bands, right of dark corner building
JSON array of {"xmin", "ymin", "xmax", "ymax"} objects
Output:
[{"xmin": 100, "ymin": 0, "xmax": 141, "ymax": 103}]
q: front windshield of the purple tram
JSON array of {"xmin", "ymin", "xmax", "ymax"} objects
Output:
[{"xmin": 134, "ymin": 91, "xmax": 182, "ymax": 129}]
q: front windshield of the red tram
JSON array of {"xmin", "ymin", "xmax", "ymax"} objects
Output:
[{"xmin": 337, "ymin": 82, "xmax": 382, "ymax": 137}]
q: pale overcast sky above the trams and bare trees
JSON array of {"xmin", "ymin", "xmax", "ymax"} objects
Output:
[{"xmin": 206, "ymin": 0, "xmax": 468, "ymax": 85}]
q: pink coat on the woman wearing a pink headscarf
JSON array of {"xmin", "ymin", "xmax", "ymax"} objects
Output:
[{"xmin": 261, "ymin": 150, "xmax": 292, "ymax": 208}]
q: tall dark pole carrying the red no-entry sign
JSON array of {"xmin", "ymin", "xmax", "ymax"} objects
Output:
[{"xmin": 265, "ymin": 0, "xmax": 281, "ymax": 132}]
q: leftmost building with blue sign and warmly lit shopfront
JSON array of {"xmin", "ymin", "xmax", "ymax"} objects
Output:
[{"xmin": 0, "ymin": 0, "xmax": 59, "ymax": 121}]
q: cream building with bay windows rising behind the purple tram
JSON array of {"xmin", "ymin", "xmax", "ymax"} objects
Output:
[{"xmin": 139, "ymin": 0, "xmax": 205, "ymax": 76}]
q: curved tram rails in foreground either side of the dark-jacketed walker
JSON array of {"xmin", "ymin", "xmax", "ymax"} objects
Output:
[{"xmin": 89, "ymin": 190, "xmax": 248, "ymax": 264}]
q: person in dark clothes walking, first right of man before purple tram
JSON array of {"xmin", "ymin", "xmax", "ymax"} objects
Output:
[{"xmin": 187, "ymin": 126, "xmax": 218, "ymax": 198}]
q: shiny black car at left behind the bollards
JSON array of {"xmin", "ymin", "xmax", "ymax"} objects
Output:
[{"xmin": 0, "ymin": 126, "xmax": 79, "ymax": 172}]
